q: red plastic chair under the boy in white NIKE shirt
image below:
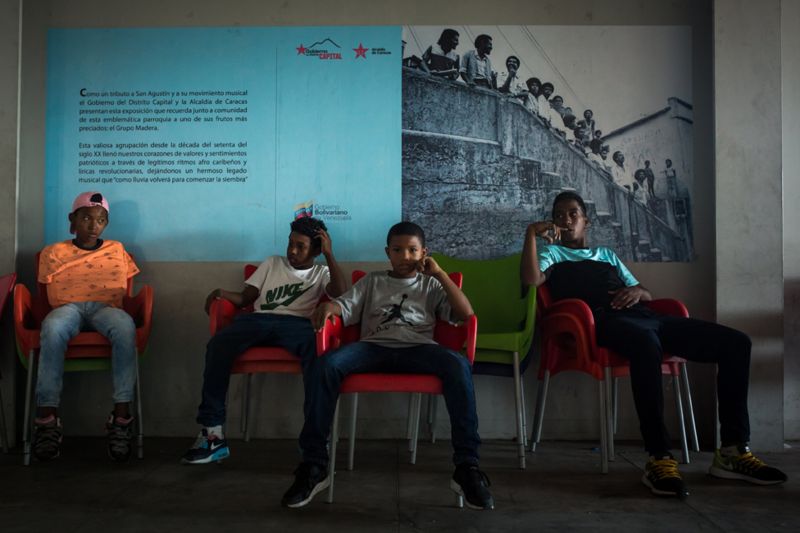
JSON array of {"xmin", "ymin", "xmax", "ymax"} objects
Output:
[{"xmin": 209, "ymin": 265, "xmax": 314, "ymax": 441}]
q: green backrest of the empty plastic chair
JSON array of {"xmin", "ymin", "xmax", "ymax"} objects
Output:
[{"xmin": 433, "ymin": 254, "xmax": 535, "ymax": 333}]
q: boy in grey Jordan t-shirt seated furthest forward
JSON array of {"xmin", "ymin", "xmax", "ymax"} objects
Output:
[{"xmin": 281, "ymin": 222, "xmax": 494, "ymax": 509}]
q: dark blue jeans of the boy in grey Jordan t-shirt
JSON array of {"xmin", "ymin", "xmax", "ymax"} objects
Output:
[{"xmin": 300, "ymin": 342, "xmax": 481, "ymax": 468}]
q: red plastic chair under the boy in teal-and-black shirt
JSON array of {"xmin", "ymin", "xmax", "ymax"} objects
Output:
[{"xmin": 531, "ymin": 285, "xmax": 700, "ymax": 474}]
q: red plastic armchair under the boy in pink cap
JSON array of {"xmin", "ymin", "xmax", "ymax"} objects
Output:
[{"xmin": 14, "ymin": 253, "xmax": 153, "ymax": 466}]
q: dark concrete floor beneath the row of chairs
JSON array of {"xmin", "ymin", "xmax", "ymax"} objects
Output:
[{"xmin": 0, "ymin": 437, "xmax": 800, "ymax": 533}]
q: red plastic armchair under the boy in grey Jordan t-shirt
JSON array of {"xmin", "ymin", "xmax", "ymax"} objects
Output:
[{"xmin": 317, "ymin": 270, "xmax": 478, "ymax": 503}]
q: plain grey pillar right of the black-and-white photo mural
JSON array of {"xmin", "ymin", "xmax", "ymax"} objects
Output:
[{"xmin": 714, "ymin": 0, "xmax": 783, "ymax": 449}]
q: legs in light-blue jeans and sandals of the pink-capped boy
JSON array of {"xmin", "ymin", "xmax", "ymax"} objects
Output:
[{"xmin": 34, "ymin": 302, "xmax": 137, "ymax": 461}]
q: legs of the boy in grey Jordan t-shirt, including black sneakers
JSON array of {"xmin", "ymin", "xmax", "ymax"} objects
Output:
[{"xmin": 282, "ymin": 342, "xmax": 494, "ymax": 508}]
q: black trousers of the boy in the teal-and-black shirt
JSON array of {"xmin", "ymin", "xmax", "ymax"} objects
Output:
[{"xmin": 595, "ymin": 309, "xmax": 751, "ymax": 456}]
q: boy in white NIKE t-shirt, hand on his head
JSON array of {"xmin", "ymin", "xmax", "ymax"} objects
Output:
[{"xmin": 181, "ymin": 217, "xmax": 347, "ymax": 464}]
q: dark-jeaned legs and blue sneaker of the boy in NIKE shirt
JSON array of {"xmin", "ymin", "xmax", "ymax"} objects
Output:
[{"xmin": 181, "ymin": 313, "xmax": 316, "ymax": 464}]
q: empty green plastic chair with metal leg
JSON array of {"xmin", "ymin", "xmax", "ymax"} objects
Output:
[{"xmin": 433, "ymin": 254, "xmax": 536, "ymax": 469}]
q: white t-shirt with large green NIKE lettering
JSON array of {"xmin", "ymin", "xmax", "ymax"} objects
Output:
[{"xmin": 245, "ymin": 255, "xmax": 331, "ymax": 318}]
